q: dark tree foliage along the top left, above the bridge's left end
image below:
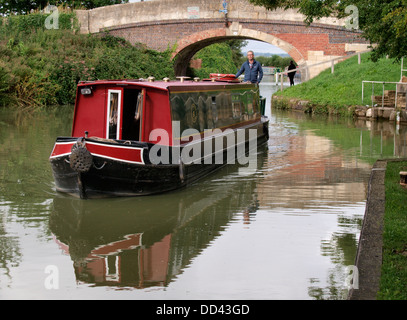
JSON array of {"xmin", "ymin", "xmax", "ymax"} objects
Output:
[{"xmin": 0, "ymin": 0, "xmax": 128, "ymax": 15}]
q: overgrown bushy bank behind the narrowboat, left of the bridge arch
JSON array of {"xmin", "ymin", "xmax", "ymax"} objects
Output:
[{"xmin": 0, "ymin": 12, "xmax": 174, "ymax": 108}]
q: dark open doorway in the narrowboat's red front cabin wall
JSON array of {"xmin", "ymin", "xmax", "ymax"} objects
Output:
[{"xmin": 122, "ymin": 89, "xmax": 144, "ymax": 141}]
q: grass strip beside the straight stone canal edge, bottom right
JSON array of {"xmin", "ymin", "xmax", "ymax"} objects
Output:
[{"xmin": 377, "ymin": 161, "xmax": 407, "ymax": 300}]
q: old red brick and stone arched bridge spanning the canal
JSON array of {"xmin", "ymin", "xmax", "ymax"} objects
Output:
[{"xmin": 76, "ymin": 0, "xmax": 368, "ymax": 77}]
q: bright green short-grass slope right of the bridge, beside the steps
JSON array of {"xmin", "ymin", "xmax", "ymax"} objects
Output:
[{"xmin": 273, "ymin": 53, "xmax": 400, "ymax": 114}]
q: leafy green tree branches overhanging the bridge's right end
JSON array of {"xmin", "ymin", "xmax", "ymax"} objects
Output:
[{"xmin": 249, "ymin": 0, "xmax": 407, "ymax": 61}]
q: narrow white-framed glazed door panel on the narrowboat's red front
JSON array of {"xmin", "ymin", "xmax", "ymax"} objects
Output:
[{"xmin": 106, "ymin": 90, "xmax": 122, "ymax": 139}]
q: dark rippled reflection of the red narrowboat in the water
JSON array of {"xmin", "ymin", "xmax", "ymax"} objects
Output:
[{"xmin": 50, "ymin": 146, "xmax": 267, "ymax": 289}]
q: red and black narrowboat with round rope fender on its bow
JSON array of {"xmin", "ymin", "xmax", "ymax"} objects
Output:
[{"xmin": 50, "ymin": 74, "xmax": 268, "ymax": 198}]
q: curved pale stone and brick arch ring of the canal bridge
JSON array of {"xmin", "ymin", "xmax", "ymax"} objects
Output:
[{"xmin": 173, "ymin": 24, "xmax": 306, "ymax": 76}]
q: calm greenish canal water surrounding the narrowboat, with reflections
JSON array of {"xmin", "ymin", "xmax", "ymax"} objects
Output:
[{"xmin": 0, "ymin": 81, "xmax": 407, "ymax": 300}]
